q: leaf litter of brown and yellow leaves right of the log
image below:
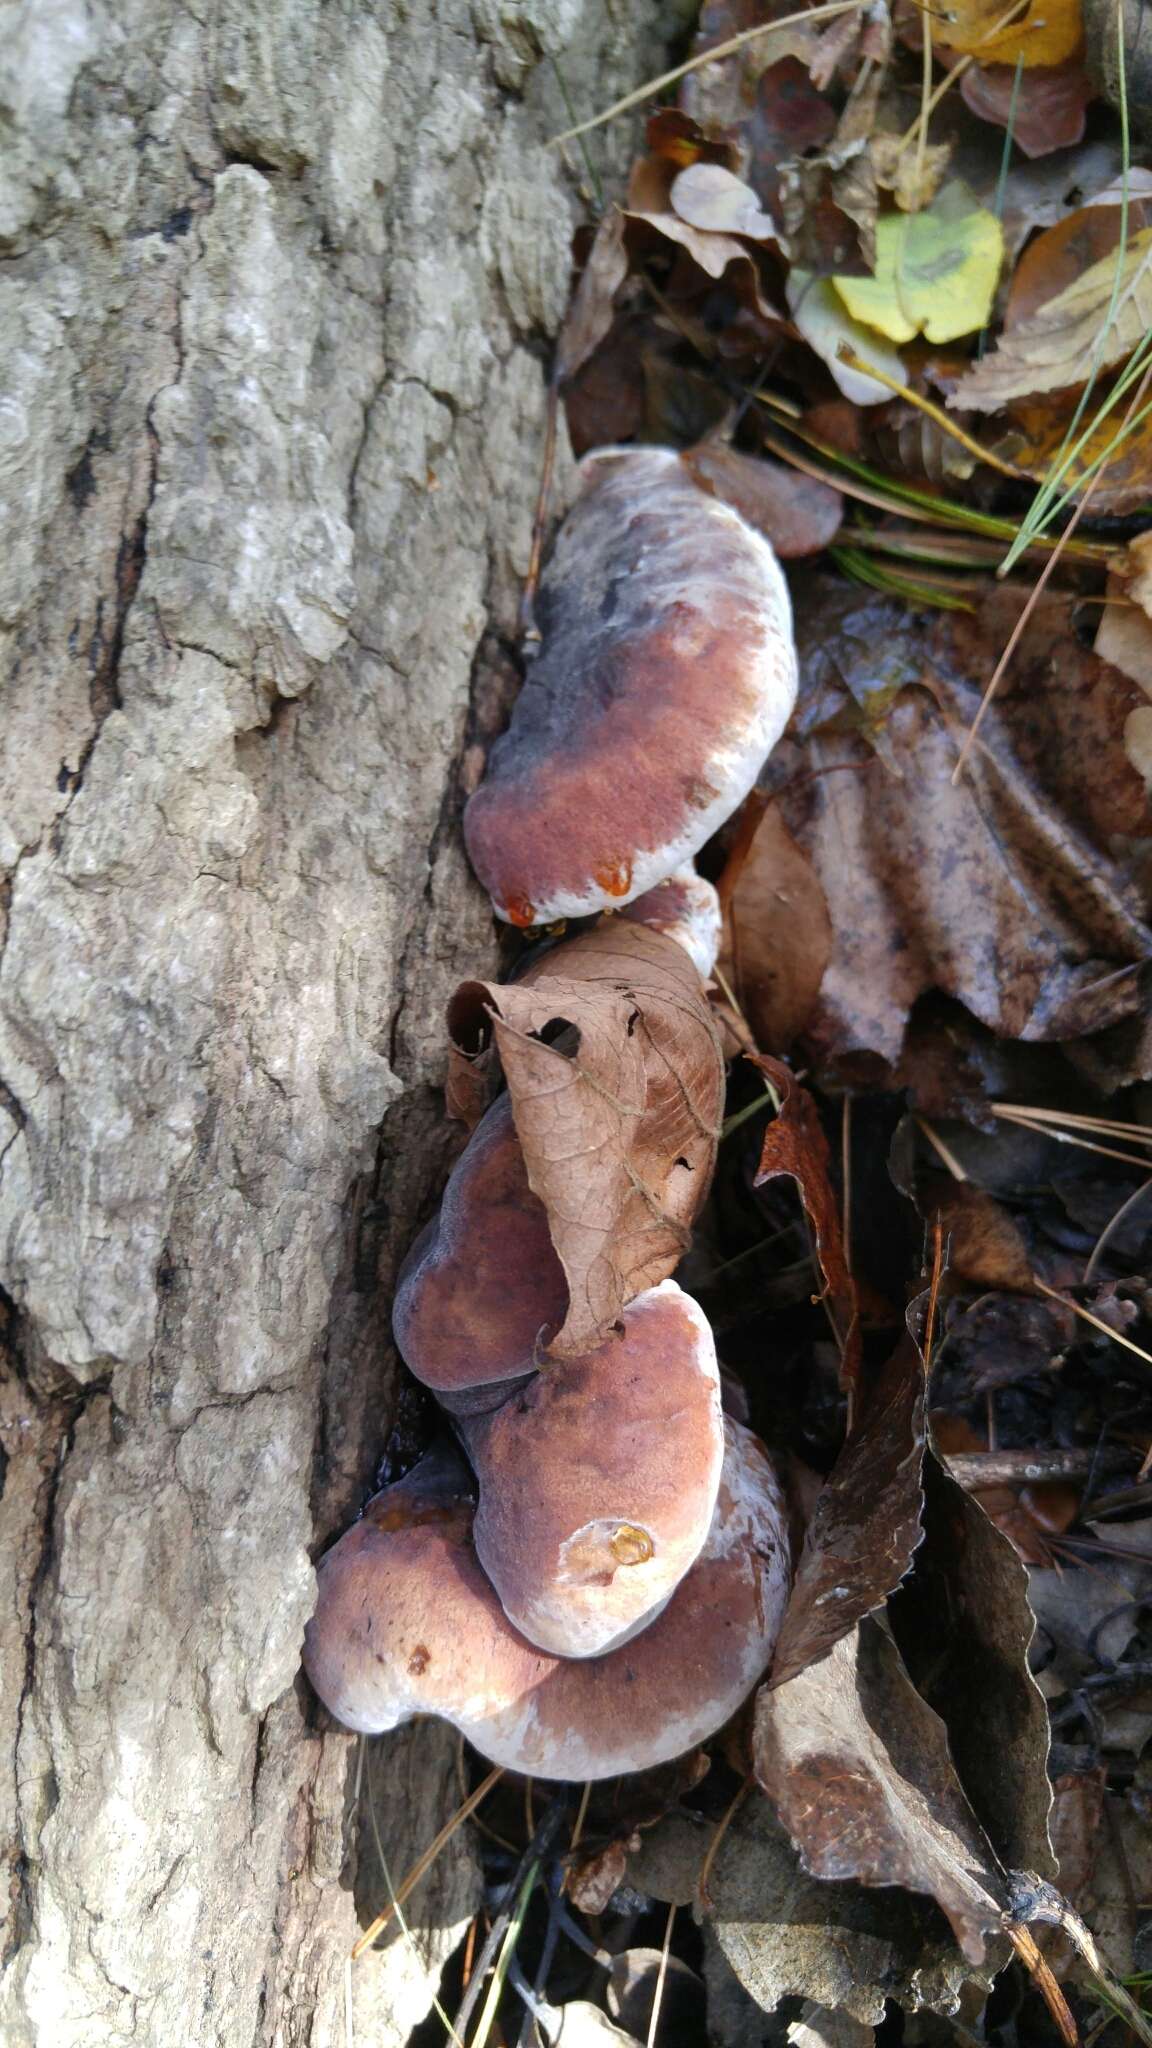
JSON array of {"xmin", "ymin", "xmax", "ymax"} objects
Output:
[{"xmin": 377, "ymin": 0, "xmax": 1152, "ymax": 2048}]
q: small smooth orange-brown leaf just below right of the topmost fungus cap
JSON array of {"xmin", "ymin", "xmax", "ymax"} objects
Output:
[{"xmin": 719, "ymin": 791, "xmax": 832, "ymax": 1053}]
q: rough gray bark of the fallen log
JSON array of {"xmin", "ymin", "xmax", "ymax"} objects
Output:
[{"xmin": 0, "ymin": 0, "xmax": 656, "ymax": 2048}]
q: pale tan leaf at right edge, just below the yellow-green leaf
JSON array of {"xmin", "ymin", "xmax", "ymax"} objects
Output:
[{"xmin": 947, "ymin": 227, "xmax": 1152, "ymax": 411}]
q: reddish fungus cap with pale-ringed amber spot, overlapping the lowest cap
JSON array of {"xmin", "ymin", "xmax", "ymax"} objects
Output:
[{"xmin": 455, "ymin": 1280, "xmax": 724, "ymax": 1657}]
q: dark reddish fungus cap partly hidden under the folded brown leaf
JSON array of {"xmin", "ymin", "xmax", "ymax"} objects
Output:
[{"xmin": 392, "ymin": 1096, "xmax": 568, "ymax": 1415}]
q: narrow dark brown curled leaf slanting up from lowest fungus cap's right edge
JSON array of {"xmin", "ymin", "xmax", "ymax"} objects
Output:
[{"xmin": 769, "ymin": 1305, "xmax": 924, "ymax": 1686}]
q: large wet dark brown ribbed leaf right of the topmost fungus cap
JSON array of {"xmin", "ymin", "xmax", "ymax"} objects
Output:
[{"xmin": 765, "ymin": 578, "xmax": 1152, "ymax": 1061}]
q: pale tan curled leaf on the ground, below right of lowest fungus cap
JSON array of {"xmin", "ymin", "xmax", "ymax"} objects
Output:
[{"xmin": 752, "ymin": 1620, "xmax": 1006, "ymax": 1964}]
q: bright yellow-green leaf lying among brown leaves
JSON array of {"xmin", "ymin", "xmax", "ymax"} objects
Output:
[{"xmin": 832, "ymin": 180, "xmax": 1004, "ymax": 342}]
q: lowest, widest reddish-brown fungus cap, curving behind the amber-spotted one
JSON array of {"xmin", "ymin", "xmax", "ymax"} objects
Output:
[{"xmin": 303, "ymin": 1423, "xmax": 787, "ymax": 1778}]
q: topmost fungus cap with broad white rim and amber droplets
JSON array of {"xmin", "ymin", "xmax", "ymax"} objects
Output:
[{"xmin": 463, "ymin": 449, "xmax": 795, "ymax": 926}]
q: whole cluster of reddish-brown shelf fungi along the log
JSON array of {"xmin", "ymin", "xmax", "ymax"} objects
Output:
[{"xmin": 305, "ymin": 449, "xmax": 795, "ymax": 1778}]
